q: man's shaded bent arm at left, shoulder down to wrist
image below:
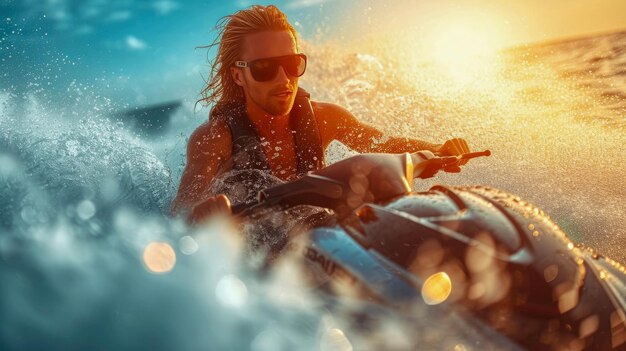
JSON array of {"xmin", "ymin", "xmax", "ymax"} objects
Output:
[{"xmin": 171, "ymin": 119, "xmax": 232, "ymax": 214}]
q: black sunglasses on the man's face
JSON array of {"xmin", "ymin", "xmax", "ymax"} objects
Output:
[{"xmin": 235, "ymin": 54, "xmax": 306, "ymax": 82}]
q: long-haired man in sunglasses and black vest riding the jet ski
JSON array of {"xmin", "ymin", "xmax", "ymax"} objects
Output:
[{"xmin": 172, "ymin": 5, "xmax": 469, "ymax": 221}]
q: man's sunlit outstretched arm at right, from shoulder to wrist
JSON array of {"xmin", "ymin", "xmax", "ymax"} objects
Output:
[{"xmin": 312, "ymin": 102, "xmax": 443, "ymax": 153}]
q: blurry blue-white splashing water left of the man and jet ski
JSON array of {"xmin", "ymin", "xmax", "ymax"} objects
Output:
[{"xmin": 0, "ymin": 92, "xmax": 510, "ymax": 350}]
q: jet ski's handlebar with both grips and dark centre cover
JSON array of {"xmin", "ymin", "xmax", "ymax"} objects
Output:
[{"xmin": 232, "ymin": 150, "xmax": 491, "ymax": 215}]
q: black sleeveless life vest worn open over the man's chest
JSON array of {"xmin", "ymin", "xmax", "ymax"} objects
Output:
[{"xmin": 211, "ymin": 88, "xmax": 324, "ymax": 177}]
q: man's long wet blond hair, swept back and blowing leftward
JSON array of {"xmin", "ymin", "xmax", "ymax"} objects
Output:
[{"xmin": 196, "ymin": 5, "xmax": 298, "ymax": 110}]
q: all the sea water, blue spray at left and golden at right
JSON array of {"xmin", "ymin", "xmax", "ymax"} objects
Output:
[{"xmin": 0, "ymin": 15, "xmax": 626, "ymax": 350}]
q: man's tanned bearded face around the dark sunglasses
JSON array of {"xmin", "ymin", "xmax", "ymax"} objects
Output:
[{"xmin": 231, "ymin": 31, "xmax": 298, "ymax": 116}]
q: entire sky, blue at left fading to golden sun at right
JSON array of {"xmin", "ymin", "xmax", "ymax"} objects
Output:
[{"xmin": 0, "ymin": 0, "xmax": 626, "ymax": 104}]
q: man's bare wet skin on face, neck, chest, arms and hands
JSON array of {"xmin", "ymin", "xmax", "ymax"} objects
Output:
[{"xmin": 172, "ymin": 31, "xmax": 469, "ymax": 222}]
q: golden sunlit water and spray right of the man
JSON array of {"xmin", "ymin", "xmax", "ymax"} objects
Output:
[{"xmin": 301, "ymin": 33, "xmax": 626, "ymax": 262}]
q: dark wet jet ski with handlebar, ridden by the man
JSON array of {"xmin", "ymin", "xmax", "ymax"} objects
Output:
[{"xmin": 233, "ymin": 151, "xmax": 626, "ymax": 350}]
